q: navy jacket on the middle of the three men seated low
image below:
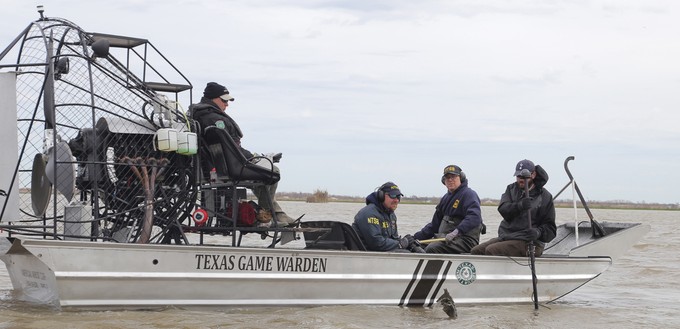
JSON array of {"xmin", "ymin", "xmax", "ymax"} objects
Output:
[{"xmin": 413, "ymin": 180, "xmax": 482, "ymax": 243}]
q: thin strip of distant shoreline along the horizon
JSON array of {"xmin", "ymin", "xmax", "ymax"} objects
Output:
[{"xmin": 276, "ymin": 192, "xmax": 680, "ymax": 211}]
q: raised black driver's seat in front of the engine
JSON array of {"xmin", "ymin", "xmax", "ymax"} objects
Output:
[{"xmin": 203, "ymin": 126, "xmax": 281, "ymax": 185}]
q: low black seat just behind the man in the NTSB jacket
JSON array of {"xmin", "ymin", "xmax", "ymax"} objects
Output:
[{"xmin": 300, "ymin": 221, "xmax": 366, "ymax": 251}]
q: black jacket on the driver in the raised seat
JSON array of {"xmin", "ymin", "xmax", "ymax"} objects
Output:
[{"xmin": 189, "ymin": 97, "xmax": 253, "ymax": 159}]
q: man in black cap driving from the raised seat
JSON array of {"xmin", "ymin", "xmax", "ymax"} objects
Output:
[{"xmin": 189, "ymin": 82, "xmax": 294, "ymax": 225}]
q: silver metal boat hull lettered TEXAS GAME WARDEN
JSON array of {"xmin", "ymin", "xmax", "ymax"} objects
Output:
[{"xmin": 1, "ymin": 239, "xmax": 611, "ymax": 309}]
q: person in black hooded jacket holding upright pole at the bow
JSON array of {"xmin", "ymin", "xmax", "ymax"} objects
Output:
[{"xmin": 471, "ymin": 159, "xmax": 557, "ymax": 257}]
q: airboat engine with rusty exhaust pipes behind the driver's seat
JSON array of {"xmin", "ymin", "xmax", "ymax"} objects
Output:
[{"xmin": 69, "ymin": 117, "xmax": 195, "ymax": 241}]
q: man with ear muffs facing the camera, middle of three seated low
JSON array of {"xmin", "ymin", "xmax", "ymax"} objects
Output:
[{"xmin": 413, "ymin": 165, "xmax": 486, "ymax": 254}]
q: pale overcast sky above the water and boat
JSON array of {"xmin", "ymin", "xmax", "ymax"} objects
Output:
[{"xmin": 0, "ymin": 0, "xmax": 680, "ymax": 203}]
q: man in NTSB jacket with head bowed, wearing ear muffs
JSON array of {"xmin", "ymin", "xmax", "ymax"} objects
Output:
[{"xmin": 352, "ymin": 182, "xmax": 424, "ymax": 252}]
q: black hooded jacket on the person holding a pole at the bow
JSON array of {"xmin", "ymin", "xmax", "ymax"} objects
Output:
[{"xmin": 498, "ymin": 165, "xmax": 557, "ymax": 245}]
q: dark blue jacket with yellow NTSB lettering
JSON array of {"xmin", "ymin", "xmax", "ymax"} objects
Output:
[{"xmin": 352, "ymin": 192, "xmax": 399, "ymax": 251}]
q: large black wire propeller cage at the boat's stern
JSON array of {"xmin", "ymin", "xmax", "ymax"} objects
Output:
[{"xmin": 0, "ymin": 17, "xmax": 198, "ymax": 242}]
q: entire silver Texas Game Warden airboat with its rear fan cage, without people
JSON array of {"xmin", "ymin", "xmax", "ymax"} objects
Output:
[{"xmin": 0, "ymin": 9, "xmax": 649, "ymax": 309}]
